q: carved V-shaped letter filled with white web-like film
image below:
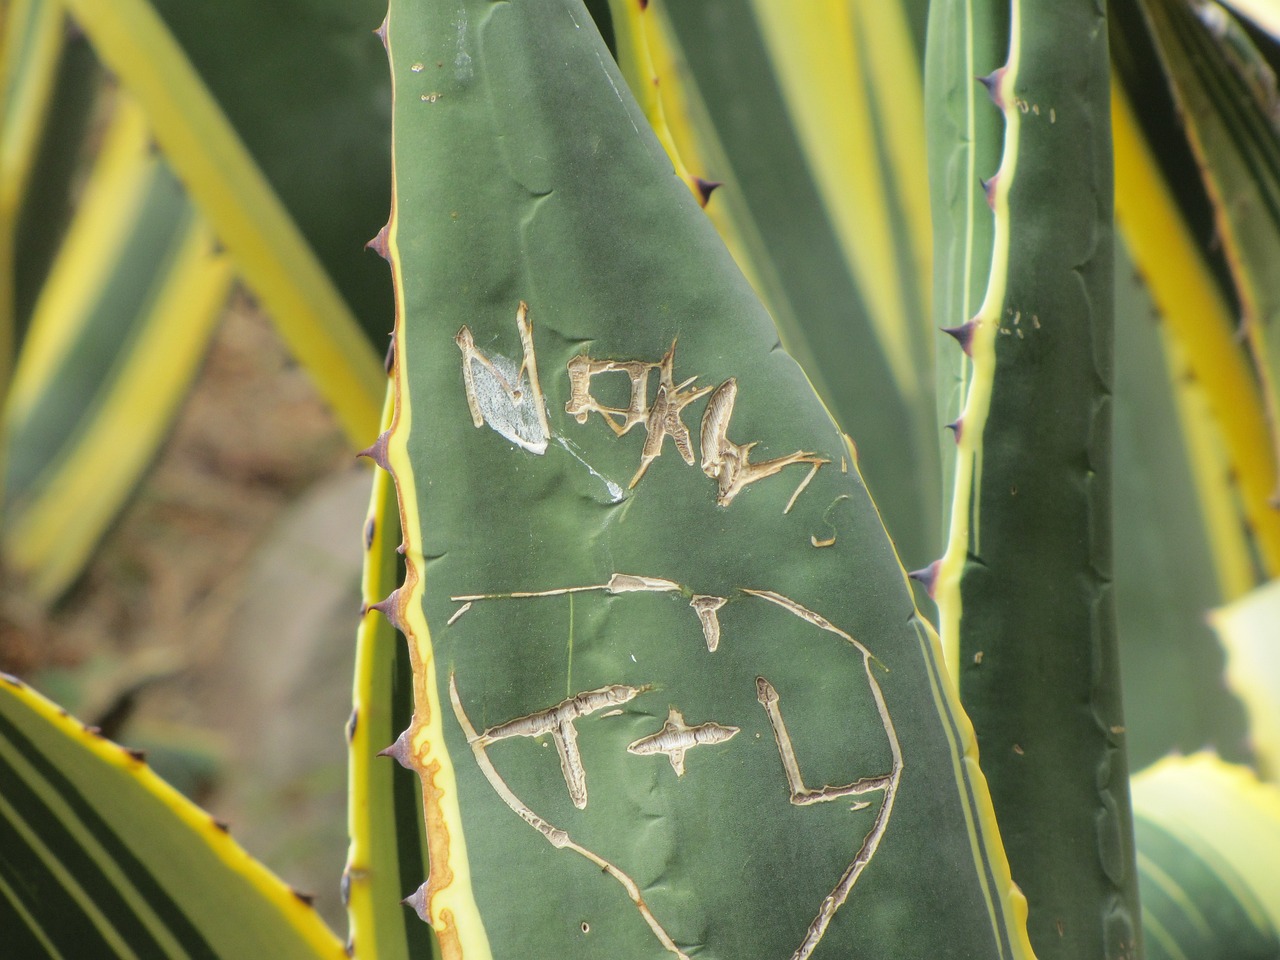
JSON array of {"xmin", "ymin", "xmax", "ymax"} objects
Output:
[{"xmin": 453, "ymin": 301, "xmax": 552, "ymax": 456}]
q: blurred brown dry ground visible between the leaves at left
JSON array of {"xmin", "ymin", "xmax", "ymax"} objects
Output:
[{"xmin": 0, "ymin": 296, "xmax": 367, "ymax": 933}]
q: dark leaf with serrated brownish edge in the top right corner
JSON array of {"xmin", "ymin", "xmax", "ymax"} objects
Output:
[{"xmin": 1126, "ymin": 0, "xmax": 1280, "ymax": 512}]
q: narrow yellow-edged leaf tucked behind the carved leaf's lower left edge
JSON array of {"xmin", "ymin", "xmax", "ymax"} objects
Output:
[{"xmin": 342, "ymin": 386, "xmax": 436, "ymax": 960}]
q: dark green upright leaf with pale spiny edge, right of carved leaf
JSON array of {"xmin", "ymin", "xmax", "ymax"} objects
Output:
[{"xmin": 923, "ymin": 3, "xmax": 1140, "ymax": 960}]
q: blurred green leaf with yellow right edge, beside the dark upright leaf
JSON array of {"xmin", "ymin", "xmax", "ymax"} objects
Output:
[{"xmin": 1115, "ymin": 236, "xmax": 1254, "ymax": 769}]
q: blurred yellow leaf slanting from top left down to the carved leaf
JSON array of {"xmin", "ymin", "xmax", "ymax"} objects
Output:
[{"xmin": 65, "ymin": 0, "xmax": 383, "ymax": 440}]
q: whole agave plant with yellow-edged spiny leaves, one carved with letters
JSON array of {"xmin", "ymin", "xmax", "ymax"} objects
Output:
[{"xmin": 0, "ymin": 0, "xmax": 1280, "ymax": 960}]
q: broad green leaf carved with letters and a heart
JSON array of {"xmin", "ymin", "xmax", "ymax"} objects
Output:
[{"xmin": 370, "ymin": 0, "xmax": 1030, "ymax": 960}]
